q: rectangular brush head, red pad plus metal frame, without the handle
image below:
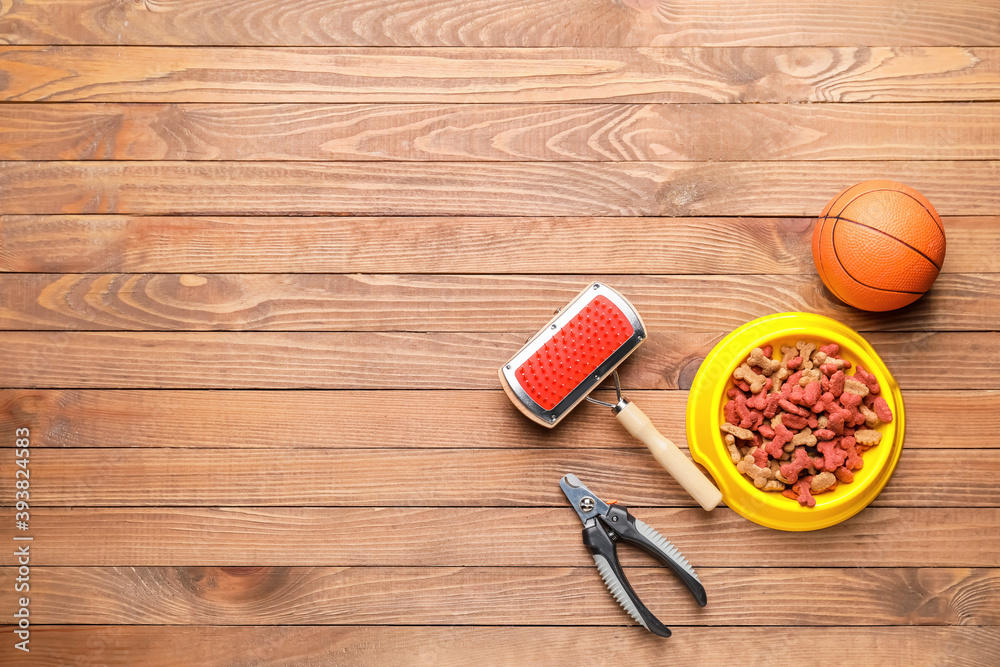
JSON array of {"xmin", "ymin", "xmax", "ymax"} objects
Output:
[{"xmin": 499, "ymin": 283, "xmax": 646, "ymax": 428}]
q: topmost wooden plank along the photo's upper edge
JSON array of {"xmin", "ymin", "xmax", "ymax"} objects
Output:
[{"xmin": 0, "ymin": 0, "xmax": 1000, "ymax": 46}]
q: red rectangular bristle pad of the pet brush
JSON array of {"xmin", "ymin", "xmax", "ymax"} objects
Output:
[{"xmin": 516, "ymin": 296, "xmax": 635, "ymax": 410}]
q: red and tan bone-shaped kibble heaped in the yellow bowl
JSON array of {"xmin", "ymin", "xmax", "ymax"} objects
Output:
[{"xmin": 722, "ymin": 340, "xmax": 892, "ymax": 507}]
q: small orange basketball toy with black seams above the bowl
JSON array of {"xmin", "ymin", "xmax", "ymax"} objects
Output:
[{"xmin": 813, "ymin": 181, "xmax": 945, "ymax": 311}]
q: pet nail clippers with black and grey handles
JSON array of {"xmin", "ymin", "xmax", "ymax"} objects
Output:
[{"xmin": 559, "ymin": 475, "xmax": 708, "ymax": 637}]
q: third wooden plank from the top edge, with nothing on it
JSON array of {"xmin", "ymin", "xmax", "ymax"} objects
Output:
[{"xmin": 0, "ymin": 102, "xmax": 1000, "ymax": 162}]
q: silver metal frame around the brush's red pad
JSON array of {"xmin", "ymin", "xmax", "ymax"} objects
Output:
[{"xmin": 503, "ymin": 283, "xmax": 646, "ymax": 426}]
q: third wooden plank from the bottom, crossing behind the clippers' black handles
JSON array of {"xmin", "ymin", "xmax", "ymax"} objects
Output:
[{"xmin": 0, "ymin": 508, "xmax": 1000, "ymax": 568}]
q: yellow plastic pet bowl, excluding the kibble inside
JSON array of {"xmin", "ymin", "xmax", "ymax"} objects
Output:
[{"xmin": 687, "ymin": 313, "xmax": 904, "ymax": 531}]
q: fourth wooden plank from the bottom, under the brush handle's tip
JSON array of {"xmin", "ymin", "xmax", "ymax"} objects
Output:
[{"xmin": 0, "ymin": 446, "xmax": 1000, "ymax": 508}]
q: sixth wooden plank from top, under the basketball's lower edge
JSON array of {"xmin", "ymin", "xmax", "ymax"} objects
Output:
[{"xmin": 0, "ymin": 272, "xmax": 1000, "ymax": 334}]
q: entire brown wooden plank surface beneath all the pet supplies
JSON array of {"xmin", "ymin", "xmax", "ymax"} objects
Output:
[{"xmin": 0, "ymin": 0, "xmax": 1000, "ymax": 667}]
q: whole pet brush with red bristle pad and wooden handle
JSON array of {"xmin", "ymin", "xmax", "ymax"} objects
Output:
[{"xmin": 498, "ymin": 283, "xmax": 722, "ymax": 510}]
